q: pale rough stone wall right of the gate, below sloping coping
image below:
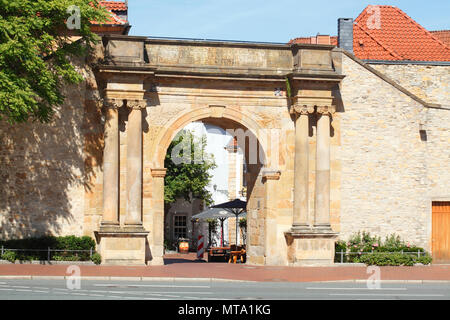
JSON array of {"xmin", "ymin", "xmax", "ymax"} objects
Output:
[{"xmin": 338, "ymin": 55, "xmax": 450, "ymax": 249}]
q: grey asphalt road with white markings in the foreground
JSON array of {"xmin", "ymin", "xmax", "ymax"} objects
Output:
[{"xmin": 0, "ymin": 280, "xmax": 450, "ymax": 300}]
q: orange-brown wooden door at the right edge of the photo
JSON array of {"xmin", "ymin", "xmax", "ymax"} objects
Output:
[{"xmin": 431, "ymin": 201, "xmax": 450, "ymax": 263}]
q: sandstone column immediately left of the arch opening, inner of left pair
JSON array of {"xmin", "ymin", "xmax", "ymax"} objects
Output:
[{"xmin": 125, "ymin": 100, "xmax": 147, "ymax": 227}]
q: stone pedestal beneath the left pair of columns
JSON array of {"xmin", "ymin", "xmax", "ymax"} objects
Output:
[{"xmin": 94, "ymin": 226, "xmax": 149, "ymax": 266}]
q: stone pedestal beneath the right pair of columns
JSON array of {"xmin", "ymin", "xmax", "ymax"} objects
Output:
[{"xmin": 285, "ymin": 229, "xmax": 337, "ymax": 266}]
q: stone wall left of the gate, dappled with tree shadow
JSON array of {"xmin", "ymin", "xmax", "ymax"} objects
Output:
[{"xmin": 0, "ymin": 59, "xmax": 101, "ymax": 239}]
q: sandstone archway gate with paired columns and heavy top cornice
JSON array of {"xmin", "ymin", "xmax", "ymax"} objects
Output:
[{"xmin": 95, "ymin": 36, "xmax": 343, "ymax": 265}]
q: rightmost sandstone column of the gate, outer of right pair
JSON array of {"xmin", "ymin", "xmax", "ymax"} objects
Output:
[{"xmin": 314, "ymin": 106, "xmax": 335, "ymax": 231}]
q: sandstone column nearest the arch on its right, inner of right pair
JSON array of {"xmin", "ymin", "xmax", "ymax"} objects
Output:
[{"xmin": 292, "ymin": 106, "xmax": 314, "ymax": 231}]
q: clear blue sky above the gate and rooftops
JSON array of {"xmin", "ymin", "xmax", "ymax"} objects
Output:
[{"xmin": 128, "ymin": 0, "xmax": 450, "ymax": 43}]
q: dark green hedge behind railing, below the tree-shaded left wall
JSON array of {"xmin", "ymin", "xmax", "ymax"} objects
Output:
[{"xmin": 0, "ymin": 236, "xmax": 95, "ymax": 261}]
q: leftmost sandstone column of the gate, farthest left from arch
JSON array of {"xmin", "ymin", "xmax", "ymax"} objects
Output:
[{"xmin": 101, "ymin": 99, "xmax": 123, "ymax": 227}]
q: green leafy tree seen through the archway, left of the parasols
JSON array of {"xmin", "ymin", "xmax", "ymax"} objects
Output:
[{"xmin": 164, "ymin": 131, "xmax": 216, "ymax": 206}]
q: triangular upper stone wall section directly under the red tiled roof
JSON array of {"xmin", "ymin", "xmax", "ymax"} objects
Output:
[{"xmin": 370, "ymin": 64, "xmax": 450, "ymax": 106}]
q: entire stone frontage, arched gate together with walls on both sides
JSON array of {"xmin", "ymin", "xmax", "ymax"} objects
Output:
[{"xmin": 0, "ymin": 5, "xmax": 450, "ymax": 265}]
